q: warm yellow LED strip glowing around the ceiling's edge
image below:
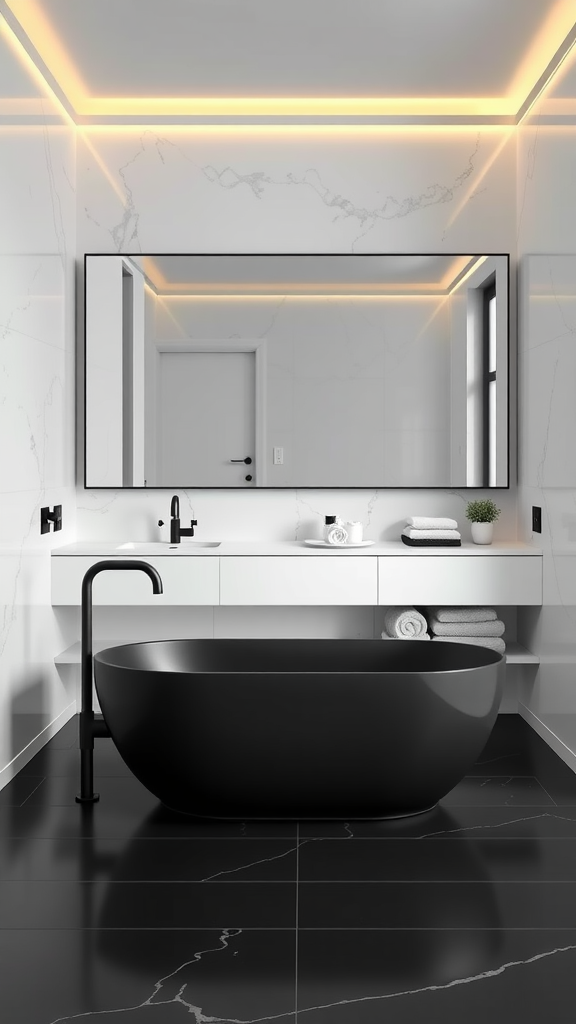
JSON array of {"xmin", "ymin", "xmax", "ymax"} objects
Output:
[{"xmin": 0, "ymin": 0, "xmax": 576, "ymax": 127}]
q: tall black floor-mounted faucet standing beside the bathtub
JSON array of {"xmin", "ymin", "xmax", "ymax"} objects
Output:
[{"xmin": 76, "ymin": 558, "xmax": 163, "ymax": 804}]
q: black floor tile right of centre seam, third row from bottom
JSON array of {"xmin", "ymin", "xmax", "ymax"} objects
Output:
[{"xmin": 298, "ymin": 838, "xmax": 576, "ymax": 883}]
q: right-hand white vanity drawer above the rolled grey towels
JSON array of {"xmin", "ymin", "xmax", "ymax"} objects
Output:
[{"xmin": 378, "ymin": 555, "xmax": 542, "ymax": 604}]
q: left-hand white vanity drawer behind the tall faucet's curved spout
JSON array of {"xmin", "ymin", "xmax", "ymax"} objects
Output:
[{"xmin": 52, "ymin": 555, "xmax": 219, "ymax": 607}]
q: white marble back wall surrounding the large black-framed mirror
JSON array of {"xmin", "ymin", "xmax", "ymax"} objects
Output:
[{"xmin": 69, "ymin": 127, "xmax": 517, "ymax": 638}]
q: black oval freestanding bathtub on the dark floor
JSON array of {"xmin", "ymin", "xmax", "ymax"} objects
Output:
[{"xmin": 94, "ymin": 640, "xmax": 504, "ymax": 820}]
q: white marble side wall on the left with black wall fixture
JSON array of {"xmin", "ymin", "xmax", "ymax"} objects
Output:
[{"xmin": 0, "ymin": 18, "xmax": 76, "ymax": 788}]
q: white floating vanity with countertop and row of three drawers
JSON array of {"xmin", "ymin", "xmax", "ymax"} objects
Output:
[{"xmin": 52, "ymin": 541, "xmax": 542, "ymax": 606}]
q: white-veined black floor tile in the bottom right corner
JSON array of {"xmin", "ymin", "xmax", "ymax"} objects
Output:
[{"xmin": 297, "ymin": 929, "xmax": 576, "ymax": 1024}]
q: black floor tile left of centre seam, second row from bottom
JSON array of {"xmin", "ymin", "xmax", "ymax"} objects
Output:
[{"xmin": 0, "ymin": 881, "xmax": 296, "ymax": 929}]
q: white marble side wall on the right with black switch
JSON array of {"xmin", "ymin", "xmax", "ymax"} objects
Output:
[{"xmin": 518, "ymin": 41, "xmax": 576, "ymax": 767}]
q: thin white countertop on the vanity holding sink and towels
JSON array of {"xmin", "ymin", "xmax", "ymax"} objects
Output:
[{"xmin": 52, "ymin": 538, "xmax": 542, "ymax": 558}]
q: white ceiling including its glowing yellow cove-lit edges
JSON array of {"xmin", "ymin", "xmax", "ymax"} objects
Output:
[{"xmin": 0, "ymin": 0, "xmax": 576, "ymax": 123}]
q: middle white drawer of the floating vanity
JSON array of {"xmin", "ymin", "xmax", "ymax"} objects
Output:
[{"xmin": 220, "ymin": 555, "xmax": 377, "ymax": 605}]
